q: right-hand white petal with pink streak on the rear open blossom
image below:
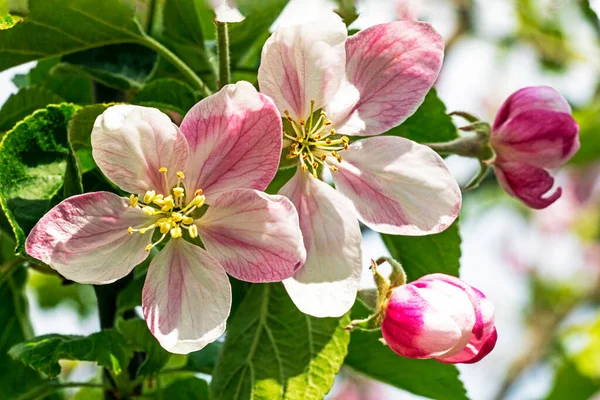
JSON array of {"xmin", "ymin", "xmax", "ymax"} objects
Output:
[{"xmin": 328, "ymin": 136, "xmax": 462, "ymax": 236}]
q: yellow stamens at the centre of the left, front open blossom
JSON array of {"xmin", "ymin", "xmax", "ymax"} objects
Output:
[{"xmin": 127, "ymin": 167, "xmax": 206, "ymax": 251}]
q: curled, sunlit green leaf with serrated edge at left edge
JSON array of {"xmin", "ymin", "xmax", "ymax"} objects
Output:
[{"xmin": 0, "ymin": 104, "xmax": 78, "ymax": 253}]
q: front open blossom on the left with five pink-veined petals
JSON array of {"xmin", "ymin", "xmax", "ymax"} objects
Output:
[{"xmin": 26, "ymin": 82, "xmax": 306, "ymax": 353}]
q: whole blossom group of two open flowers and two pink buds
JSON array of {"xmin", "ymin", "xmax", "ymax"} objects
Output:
[{"xmin": 26, "ymin": 13, "xmax": 578, "ymax": 363}]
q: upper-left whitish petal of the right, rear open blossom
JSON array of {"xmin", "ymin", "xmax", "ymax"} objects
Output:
[{"xmin": 258, "ymin": 12, "xmax": 348, "ymax": 119}]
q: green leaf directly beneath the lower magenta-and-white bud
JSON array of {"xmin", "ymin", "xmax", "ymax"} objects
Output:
[{"xmin": 344, "ymin": 302, "xmax": 468, "ymax": 400}]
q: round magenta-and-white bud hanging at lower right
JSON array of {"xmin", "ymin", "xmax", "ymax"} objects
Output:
[{"xmin": 381, "ymin": 274, "xmax": 497, "ymax": 363}]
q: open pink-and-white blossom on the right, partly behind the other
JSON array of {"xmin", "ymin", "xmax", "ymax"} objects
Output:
[{"xmin": 258, "ymin": 13, "xmax": 461, "ymax": 317}]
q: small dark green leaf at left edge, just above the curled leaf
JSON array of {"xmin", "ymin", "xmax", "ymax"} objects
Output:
[{"xmin": 0, "ymin": 86, "xmax": 64, "ymax": 132}]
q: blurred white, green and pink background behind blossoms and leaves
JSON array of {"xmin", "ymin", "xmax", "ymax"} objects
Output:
[{"xmin": 0, "ymin": 0, "xmax": 600, "ymax": 400}]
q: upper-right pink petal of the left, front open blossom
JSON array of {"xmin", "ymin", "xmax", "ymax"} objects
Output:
[{"xmin": 181, "ymin": 81, "xmax": 282, "ymax": 204}]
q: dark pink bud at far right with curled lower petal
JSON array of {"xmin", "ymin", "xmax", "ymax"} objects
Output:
[{"xmin": 490, "ymin": 86, "xmax": 579, "ymax": 209}]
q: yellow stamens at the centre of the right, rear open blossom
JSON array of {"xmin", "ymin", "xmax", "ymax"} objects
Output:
[{"xmin": 283, "ymin": 100, "xmax": 350, "ymax": 178}]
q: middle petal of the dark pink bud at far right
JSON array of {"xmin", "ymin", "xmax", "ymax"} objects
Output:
[{"xmin": 491, "ymin": 110, "xmax": 579, "ymax": 168}]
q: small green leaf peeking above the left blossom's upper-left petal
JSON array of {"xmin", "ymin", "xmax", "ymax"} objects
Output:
[{"xmin": 132, "ymin": 78, "xmax": 198, "ymax": 117}]
